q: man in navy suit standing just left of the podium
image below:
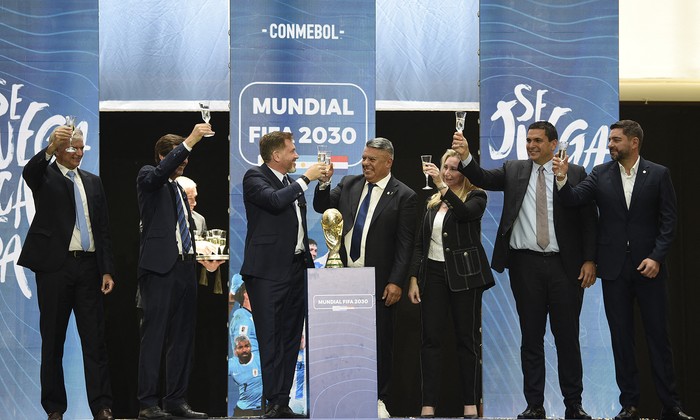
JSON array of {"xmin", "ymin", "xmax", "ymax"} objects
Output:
[{"xmin": 241, "ymin": 131, "xmax": 325, "ymax": 418}]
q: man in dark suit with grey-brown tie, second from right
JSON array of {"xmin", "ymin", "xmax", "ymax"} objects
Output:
[{"xmin": 452, "ymin": 121, "xmax": 596, "ymax": 419}]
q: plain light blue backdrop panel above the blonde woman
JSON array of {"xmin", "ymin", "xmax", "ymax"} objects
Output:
[{"xmin": 377, "ymin": 0, "xmax": 479, "ymax": 104}]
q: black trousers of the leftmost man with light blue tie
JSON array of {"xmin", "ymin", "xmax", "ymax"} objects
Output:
[{"xmin": 36, "ymin": 256, "xmax": 112, "ymax": 415}]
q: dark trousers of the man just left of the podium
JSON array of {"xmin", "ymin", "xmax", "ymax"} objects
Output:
[{"xmin": 243, "ymin": 254, "xmax": 307, "ymax": 405}]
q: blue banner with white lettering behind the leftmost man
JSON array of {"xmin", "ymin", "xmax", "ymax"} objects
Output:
[{"xmin": 0, "ymin": 0, "xmax": 99, "ymax": 419}]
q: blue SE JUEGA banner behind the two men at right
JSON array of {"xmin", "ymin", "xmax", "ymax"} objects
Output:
[{"xmin": 480, "ymin": 0, "xmax": 619, "ymax": 417}]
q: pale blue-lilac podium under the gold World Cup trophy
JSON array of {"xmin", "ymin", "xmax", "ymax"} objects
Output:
[{"xmin": 306, "ymin": 267, "xmax": 377, "ymax": 418}]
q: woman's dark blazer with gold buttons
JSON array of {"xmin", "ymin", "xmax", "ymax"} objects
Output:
[{"xmin": 410, "ymin": 190, "xmax": 495, "ymax": 292}]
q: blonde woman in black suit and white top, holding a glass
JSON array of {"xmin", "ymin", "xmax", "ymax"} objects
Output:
[{"xmin": 408, "ymin": 149, "xmax": 494, "ymax": 418}]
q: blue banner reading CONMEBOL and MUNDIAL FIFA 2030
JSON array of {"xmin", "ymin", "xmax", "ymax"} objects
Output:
[{"xmin": 230, "ymin": 0, "xmax": 375, "ymax": 414}]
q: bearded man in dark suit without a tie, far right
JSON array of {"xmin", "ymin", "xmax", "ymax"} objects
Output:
[{"xmin": 555, "ymin": 120, "xmax": 692, "ymax": 420}]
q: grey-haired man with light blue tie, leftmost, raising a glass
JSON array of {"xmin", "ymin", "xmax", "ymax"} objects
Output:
[{"xmin": 18, "ymin": 126, "xmax": 114, "ymax": 420}]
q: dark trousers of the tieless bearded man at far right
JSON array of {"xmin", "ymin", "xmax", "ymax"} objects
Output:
[{"xmin": 603, "ymin": 255, "xmax": 681, "ymax": 407}]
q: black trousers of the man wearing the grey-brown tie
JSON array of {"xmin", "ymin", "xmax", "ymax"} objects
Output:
[{"xmin": 510, "ymin": 250, "xmax": 583, "ymax": 407}]
